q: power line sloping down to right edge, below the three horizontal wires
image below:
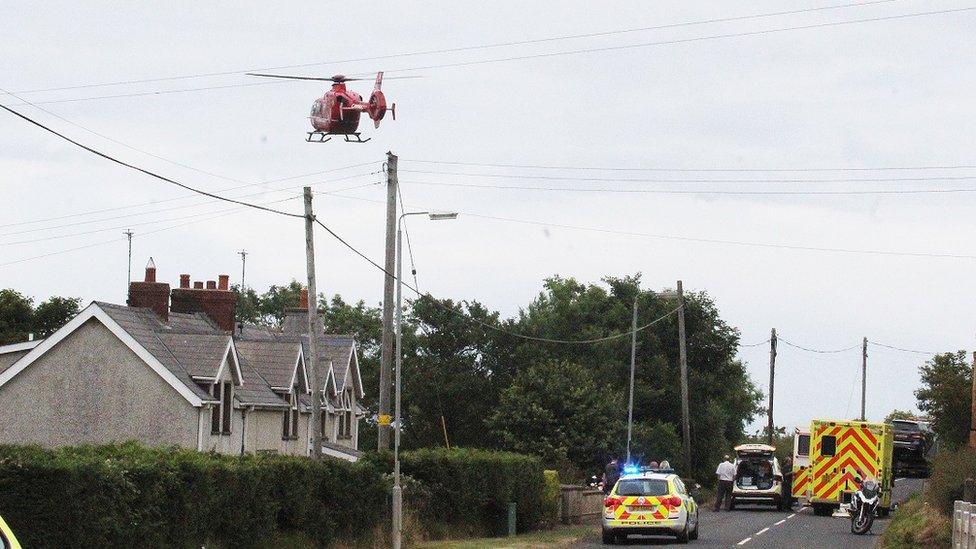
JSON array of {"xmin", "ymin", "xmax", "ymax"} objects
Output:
[{"xmin": 326, "ymin": 194, "xmax": 976, "ymax": 260}]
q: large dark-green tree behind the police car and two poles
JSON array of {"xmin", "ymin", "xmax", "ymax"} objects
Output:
[{"xmin": 508, "ymin": 274, "xmax": 761, "ymax": 479}]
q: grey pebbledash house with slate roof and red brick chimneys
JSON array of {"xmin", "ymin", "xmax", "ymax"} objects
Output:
[{"xmin": 0, "ymin": 260, "xmax": 365, "ymax": 461}]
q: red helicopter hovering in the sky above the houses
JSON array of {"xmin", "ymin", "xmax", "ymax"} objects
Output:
[{"xmin": 248, "ymin": 72, "xmax": 400, "ymax": 143}]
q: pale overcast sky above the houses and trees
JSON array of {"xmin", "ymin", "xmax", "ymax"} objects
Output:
[{"xmin": 0, "ymin": 0, "xmax": 976, "ymax": 432}]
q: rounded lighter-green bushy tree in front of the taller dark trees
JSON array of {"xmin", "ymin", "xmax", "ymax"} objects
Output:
[{"xmin": 489, "ymin": 360, "xmax": 624, "ymax": 470}]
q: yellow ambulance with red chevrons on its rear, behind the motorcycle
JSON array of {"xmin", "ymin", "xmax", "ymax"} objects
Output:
[{"xmin": 794, "ymin": 419, "xmax": 894, "ymax": 516}]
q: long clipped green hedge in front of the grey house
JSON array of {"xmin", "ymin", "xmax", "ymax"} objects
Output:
[{"xmin": 0, "ymin": 443, "xmax": 388, "ymax": 547}]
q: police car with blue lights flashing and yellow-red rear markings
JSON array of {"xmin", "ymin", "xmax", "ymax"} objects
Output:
[{"xmin": 603, "ymin": 468, "xmax": 698, "ymax": 544}]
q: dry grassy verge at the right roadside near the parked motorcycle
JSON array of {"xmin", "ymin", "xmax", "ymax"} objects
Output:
[{"xmin": 878, "ymin": 494, "xmax": 952, "ymax": 549}]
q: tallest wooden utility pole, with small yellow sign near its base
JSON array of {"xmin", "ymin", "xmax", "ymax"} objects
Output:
[{"xmin": 377, "ymin": 152, "xmax": 399, "ymax": 452}]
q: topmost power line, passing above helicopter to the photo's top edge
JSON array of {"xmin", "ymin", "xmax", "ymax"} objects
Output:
[{"xmin": 7, "ymin": 0, "xmax": 896, "ymax": 94}]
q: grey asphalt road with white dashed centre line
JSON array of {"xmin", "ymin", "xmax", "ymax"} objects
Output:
[{"xmin": 577, "ymin": 479, "xmax": 922, "ymax": 549}]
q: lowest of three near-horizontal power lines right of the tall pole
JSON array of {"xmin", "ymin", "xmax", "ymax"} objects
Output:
[{"xmin": 401, "ymin": 177, "xmax": 976, "ymax": 196}]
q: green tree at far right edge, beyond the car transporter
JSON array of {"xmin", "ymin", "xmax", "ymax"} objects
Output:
[{"xmin": 915, "ymin": 351, "xmax": 973, "ymax": 448}]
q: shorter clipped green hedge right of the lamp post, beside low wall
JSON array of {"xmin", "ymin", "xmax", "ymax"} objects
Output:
[{"xmin": 371, "ymin": 448, "xmax": 548, "ymax": 536}]
